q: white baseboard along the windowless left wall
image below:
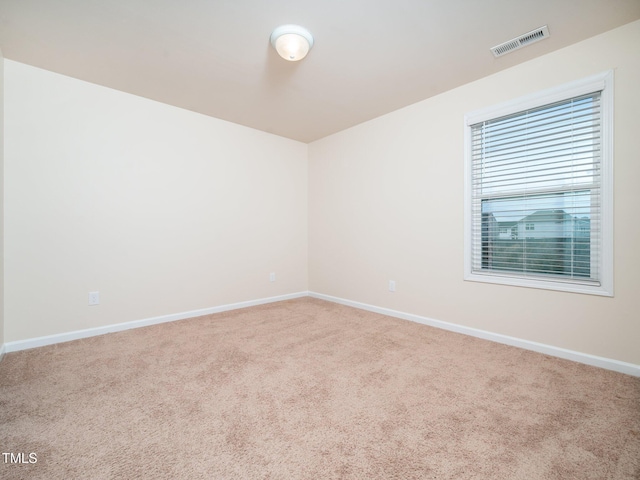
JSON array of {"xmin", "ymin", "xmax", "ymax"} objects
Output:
[{"xmin": 0, "ymin": 292, "xmax": 308, "ymax": 353}]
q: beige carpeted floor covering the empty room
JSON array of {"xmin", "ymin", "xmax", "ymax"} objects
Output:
[{"xmin": 0, "ymin": 298, "xmax": 640, "ymax": 480}]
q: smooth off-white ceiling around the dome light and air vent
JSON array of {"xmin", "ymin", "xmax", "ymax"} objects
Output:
[{"xmin": 0, "ymin": 0, "xmax": 640, "ymax": 142}]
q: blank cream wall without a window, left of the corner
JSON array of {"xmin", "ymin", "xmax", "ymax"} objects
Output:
[{"xmin": 4, "ymin": 60, "xmax": 308, "ymax": 342}]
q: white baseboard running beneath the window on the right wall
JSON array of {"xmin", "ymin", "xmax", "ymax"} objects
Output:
[{"xmin": 309, "ymin": 292, "xmax": 640, "ymax": 377}]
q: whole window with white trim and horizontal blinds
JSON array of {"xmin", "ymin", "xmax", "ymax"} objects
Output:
[{"xmin": 465, "ymin": 72, "xmax": 613, "ymax": 296}]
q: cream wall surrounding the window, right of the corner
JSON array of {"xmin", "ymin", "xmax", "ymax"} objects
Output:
[{"xmin": 309, "ymin": 22, "xmax": 640, "ymax": 364}]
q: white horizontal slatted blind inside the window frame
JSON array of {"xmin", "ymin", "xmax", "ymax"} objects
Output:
[{"xmin": 470, "ymin": 91, "xmax": 602, "ymax": 285}]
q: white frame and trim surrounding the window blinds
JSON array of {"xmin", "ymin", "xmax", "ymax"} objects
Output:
[{"xmin": 464, "ymin": 70, "xmax": 614, "ymax": 297}]
